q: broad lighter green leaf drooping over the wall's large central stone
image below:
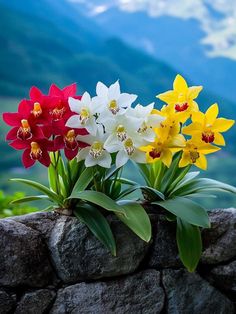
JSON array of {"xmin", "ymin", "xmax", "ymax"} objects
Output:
[{"xmin": 116, "ymin": 200, "xmax": 152, "ymax": 242}]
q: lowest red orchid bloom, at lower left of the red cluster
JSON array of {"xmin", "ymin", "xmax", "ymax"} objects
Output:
[{"xmin": 9, "ymin": 138, "xmax": 57, "ymax": 168}]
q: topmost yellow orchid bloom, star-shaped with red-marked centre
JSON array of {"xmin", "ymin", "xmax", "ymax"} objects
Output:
[{"xmin": 156, "ymin": 74, "xmax": 202, "ymax": 122}]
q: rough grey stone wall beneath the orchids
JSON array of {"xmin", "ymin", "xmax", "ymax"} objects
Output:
[{"xmin": 0, "ymin": 209, "xmax": 236, "ymax": 314}]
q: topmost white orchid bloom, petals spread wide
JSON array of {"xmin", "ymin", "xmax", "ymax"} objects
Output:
[{"xmin": 93, "ymin": 81, "xmax": 137, "ymax": 118}]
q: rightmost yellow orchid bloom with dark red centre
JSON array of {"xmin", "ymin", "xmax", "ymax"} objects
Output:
[{"xmin": 183, "ymin": 104, "xmax": 235, "ymax": 145}]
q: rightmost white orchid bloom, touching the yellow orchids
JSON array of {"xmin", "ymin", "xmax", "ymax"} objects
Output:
[{"xmin": 127, "ymin": 102, "xmax": 164, "ymax": 142}]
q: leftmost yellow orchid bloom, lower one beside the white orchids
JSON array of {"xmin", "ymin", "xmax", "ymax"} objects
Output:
[{"xmin": 140, "ymin": 127, "xmax": 185, "ymax": 167}]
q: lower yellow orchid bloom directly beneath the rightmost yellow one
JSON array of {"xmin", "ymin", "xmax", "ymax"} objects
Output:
[{"xmin": 179, "ymin": 139, "xmax": 220, "ymax": 170}]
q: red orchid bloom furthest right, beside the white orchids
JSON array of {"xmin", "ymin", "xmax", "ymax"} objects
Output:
[{"xmin": 55, "ymin": 127, "xmax": 88, "ymax": 160}]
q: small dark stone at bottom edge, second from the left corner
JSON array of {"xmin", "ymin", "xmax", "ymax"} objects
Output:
[{"xmin": 15, "ymin": 289, "xmax": 56, "ymax": 314}]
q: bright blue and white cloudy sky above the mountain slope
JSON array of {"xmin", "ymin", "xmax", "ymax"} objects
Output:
[{"xmin": 68, "ymin": 0, "xmax": 236, "ymax": 60}]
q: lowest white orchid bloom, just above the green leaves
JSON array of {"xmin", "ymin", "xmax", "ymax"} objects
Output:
[{"xmin": 77, "ymin": 126, "xmax": 112, "ymax": 168}]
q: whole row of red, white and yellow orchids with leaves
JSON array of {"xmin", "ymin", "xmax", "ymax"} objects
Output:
[{"xmin": 3, "ymin": 75, "xmax": 236, "ymax": 271}]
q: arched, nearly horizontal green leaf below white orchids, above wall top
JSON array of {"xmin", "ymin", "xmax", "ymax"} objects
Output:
[{"xmin": 68, "ymin": 190, "xmax": 125, "ymax": 215}]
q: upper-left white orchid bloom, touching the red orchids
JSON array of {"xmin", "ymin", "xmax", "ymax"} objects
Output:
[{"xmin": 66, "ymin": 92, "xmax": 97, "ymax": 135}]
